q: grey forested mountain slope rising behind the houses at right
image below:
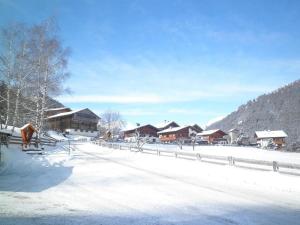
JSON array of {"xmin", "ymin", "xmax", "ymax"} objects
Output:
[{"xmin": 207, "ymin": 80, "xmax": 300, "ymax": 143}]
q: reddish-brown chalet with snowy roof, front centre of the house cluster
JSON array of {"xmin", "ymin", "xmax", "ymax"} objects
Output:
[{"xmin": 157, "ymin": 126, "xmax": 197, "ymax": 142}]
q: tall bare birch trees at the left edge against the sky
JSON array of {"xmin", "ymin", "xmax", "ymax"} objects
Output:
[{"xmin": 0, "ymin": 19, "xmax": 70, "ymax": 133}]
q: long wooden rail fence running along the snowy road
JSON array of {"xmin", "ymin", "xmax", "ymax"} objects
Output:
[{"xmin": 93, "ymin": 141, "xmax": 300, "ymax": 172}]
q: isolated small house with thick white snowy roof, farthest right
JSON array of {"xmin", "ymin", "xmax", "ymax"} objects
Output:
[{"xmin": 254, "ymin": 130, "xmax": 288, "ymax": 148}]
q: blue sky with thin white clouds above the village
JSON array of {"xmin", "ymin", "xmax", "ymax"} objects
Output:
[{"xmin": 0, "ymin": 0, "xmax": 300, "ymax": 125}]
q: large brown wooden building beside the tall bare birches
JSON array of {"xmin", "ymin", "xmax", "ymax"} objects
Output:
[{"xmin": 47, "ymin": 108, "xmax": 100, "ymax": 137}]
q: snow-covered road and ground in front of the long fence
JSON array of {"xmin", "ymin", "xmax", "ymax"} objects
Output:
[{"xmin": 0, "ymin": 143, "xmax": 300, "ymax": 225}]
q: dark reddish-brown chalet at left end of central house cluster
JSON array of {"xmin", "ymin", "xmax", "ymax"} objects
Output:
[{"xmin": 123, "ymin": 124, "xmax": 158, "ymax": 142}]
